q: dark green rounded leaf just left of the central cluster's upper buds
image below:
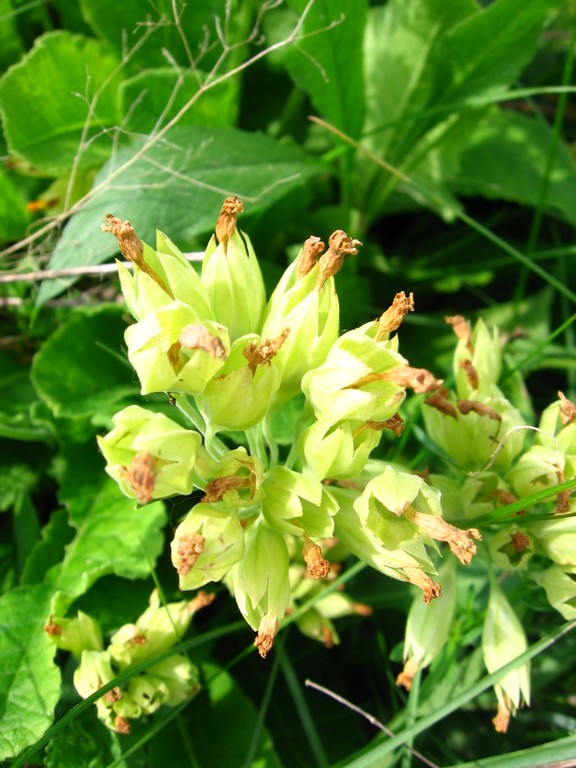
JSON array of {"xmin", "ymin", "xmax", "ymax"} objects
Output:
[{"xmin": 31, "ymin": 305, "xmax": 135, "ymax": 418}]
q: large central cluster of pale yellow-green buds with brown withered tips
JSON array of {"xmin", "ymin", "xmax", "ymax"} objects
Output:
[{"xmin": 98, "ymin": 198, "xmax": 490, "ymax": 712}]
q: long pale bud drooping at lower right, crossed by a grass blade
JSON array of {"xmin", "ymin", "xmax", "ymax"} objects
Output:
[{"xmin": 482, "ymin": 580, "xmax": 530, "ymax": 733}]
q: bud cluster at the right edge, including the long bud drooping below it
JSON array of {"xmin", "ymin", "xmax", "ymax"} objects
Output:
[{"xmin": 420, "ymin": 317, "xmax": 576, "ymax": 732}]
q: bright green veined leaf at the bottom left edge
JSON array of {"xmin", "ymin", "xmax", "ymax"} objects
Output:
[{"xmin": 0, "ymin": 585, "xmax": 60, "ymax": 760}]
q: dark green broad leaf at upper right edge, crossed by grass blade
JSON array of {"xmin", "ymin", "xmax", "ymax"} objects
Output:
[{"xmin": 430, "ymin": 109, "xmax": 576, "ymax": 224}]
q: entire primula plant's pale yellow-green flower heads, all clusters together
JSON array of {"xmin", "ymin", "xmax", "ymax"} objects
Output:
[{"xmin": 89, "ymin": 197, "xmax": 576, "ymax": 730}]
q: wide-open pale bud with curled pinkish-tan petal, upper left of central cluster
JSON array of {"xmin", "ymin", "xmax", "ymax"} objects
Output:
[{"xmin": 124, "ymin": 301, "xmax": 230, "ymax": 395}]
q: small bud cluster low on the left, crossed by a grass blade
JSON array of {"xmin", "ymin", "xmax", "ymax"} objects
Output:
[{"xmin": 44, "ymin": 592, "xmax": 213, "ymax": 734}]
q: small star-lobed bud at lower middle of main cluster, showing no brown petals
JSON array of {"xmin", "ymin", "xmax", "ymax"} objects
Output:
[{"xmin": 262, "ymin": 465, "xmax": 338, "ymax": 538}]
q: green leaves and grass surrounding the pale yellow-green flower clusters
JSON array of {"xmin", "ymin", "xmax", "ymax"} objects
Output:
[{"xmin": 0, "ymin": 0, "xmax": 576, "ymax": 768}]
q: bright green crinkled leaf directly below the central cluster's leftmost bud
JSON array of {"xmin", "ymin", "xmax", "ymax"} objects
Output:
[{"xmin": 46, "ymin": 473, "xmax": 166, "ymax": 612}]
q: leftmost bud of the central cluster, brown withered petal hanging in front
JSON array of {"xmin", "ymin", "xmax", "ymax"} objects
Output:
[{"xmin": 97, "ymin": 405, "xmax": 202, "ymax": 504}]
